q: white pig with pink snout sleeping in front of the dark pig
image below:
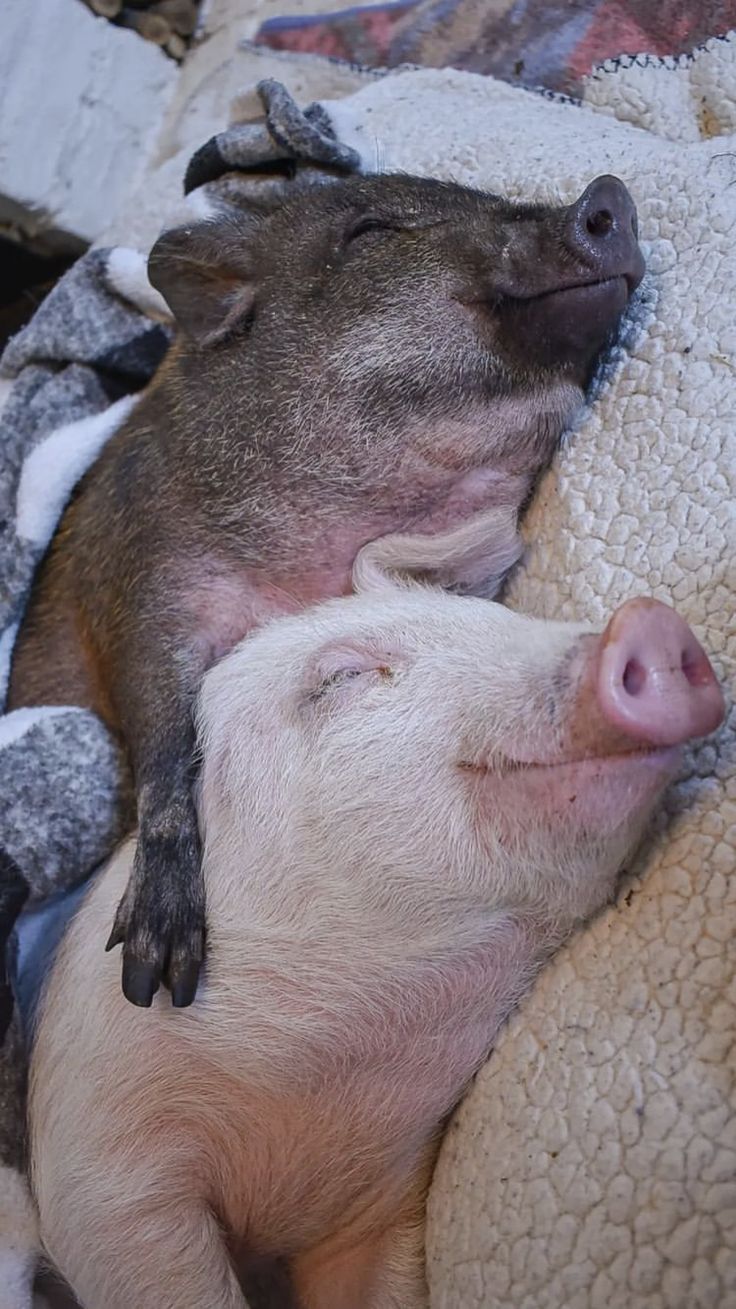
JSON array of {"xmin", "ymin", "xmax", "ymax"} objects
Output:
[{"xmin": 30, "ymin": 534, "xmax": 723, "ymax": 1309}]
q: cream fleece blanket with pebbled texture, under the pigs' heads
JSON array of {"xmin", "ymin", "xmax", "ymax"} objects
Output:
[{"xmin": 320, "ymin": 39, "xmax": 736, "ymax": 1309}]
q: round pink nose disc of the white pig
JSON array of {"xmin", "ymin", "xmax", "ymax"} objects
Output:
[{"xmin": 596, "ymin": 600, "xmax": 724, "ymax": 747}]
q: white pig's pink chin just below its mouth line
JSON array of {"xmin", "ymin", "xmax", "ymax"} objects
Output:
[{"xmin": 466, "ymin": 746, "xmax": 681, "ymax": 836}]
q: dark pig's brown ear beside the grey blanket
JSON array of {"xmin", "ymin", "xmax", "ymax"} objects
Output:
[{"xmin": 148, "ymin": 220, "xmax": 255, "ymax": 346}]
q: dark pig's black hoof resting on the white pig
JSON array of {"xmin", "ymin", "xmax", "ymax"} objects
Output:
[{"xmin": 106, "ymin": 873, "xmax": 204, "ymax": 1009}]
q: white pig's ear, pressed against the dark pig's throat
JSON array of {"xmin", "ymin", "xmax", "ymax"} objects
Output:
[{"xmin": 352, "ymin": 505, "xmax": 523, "ymax": 600}]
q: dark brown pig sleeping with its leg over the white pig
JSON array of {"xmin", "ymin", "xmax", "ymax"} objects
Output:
[{"xmin": 9, "ymin": 177, "xmax": 643, "ymax": 1005}]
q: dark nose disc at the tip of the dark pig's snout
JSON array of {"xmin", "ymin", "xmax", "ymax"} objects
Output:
[{"xmin": 566, "ymin": 175, "xmax": 644, "ymax": 293}]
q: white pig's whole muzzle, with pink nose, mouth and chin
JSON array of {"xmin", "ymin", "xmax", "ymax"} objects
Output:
[{"xmin": 462, "ymin": 600, "xmax": 724, "ymax": 838}]
